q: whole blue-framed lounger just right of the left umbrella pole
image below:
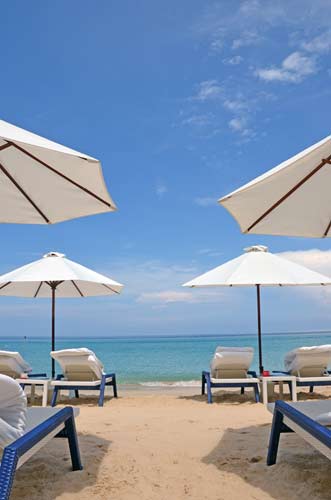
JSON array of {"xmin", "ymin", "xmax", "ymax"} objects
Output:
[{"xmin": 51, "ymin": 347, "xmax": 117, "ymax": 406}]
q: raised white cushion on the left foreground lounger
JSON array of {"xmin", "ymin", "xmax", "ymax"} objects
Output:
[{"xmin": 0, "ymin": 375, "xmax": 26, "ymax": 448}]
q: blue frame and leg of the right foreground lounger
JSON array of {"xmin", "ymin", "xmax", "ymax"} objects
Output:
[{"xmin": 267, "ymin": 401, "xmax": 331, "ymax": 465}]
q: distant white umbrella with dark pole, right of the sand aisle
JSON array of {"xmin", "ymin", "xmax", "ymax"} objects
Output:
[{"xmin": 183, "ymin": 245, "xmax": 331, "ymax": 373}]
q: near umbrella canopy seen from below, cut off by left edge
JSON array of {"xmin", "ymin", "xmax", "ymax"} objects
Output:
[{"xmin": 0, "ymin": 120, "xmax": 116, "ymax": 224}]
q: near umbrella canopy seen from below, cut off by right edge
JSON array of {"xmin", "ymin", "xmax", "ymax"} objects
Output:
[{"xmin": 219, "ymin": 136, "xmax": 331, "ymax": 238}]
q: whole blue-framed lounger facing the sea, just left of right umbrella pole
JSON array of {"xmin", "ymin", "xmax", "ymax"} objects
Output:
[{"xmin": 201, "ymin": 346, "xmax": 260, "ymax": 404}]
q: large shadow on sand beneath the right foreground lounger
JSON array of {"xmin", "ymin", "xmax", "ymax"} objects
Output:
[{"xmin": 203, "ymin": 392, "xmax": 331, "ymax": 500}]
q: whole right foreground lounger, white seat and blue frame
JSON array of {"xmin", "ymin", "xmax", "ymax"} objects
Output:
[{"xmin": 267, "ymin": 400, "xmax": 331, "ymax": 465}]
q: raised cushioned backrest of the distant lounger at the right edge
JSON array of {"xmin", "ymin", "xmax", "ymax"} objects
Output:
[{"xmin": 284, "ymin": 344, "xmax": 331, "ymax": 377}]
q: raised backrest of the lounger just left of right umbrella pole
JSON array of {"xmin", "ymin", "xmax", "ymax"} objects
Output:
[{"xmin": 210, "ymin": 346, "xmax": 254, "ymax": 378}]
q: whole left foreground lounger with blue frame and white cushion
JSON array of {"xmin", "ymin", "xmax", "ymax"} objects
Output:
[{"xmin": 0, "ymin": 375, "xmax": 82, "ymax": 500}]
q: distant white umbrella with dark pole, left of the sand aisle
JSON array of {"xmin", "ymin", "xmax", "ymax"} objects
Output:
[{"xmin": 0, "ymin": 252, "xmax": 123, "ymax": 377}]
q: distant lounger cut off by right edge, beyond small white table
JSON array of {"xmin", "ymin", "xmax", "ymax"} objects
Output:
[{"xmin": 278, "ymin": 344, "xmax": 331, "ymax": 392}]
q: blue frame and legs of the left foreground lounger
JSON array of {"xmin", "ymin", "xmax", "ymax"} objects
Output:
[{"xmin": 0, "ymin": 406, "xmax": 83, "ymax": 500}]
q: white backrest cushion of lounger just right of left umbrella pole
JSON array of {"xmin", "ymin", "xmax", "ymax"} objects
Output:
[{"xmin": 51, "ymin": 347, "xmax": 104, "ymax": 379}]
